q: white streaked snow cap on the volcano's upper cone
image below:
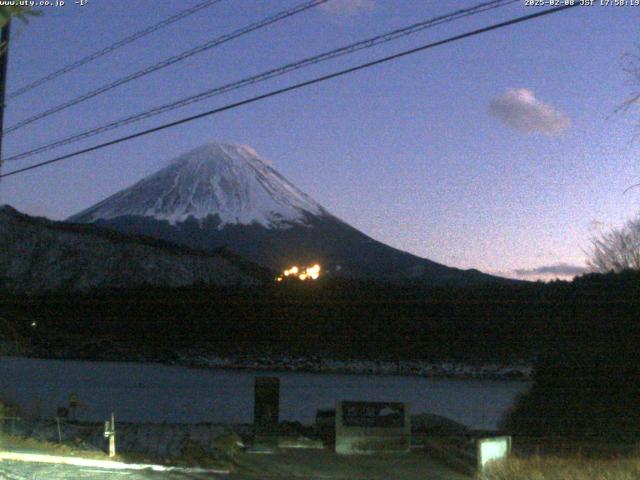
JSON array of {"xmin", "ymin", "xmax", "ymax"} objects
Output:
[{"xmin": 70, "ymin": 143, "xmax": 327, "ymax": 228}]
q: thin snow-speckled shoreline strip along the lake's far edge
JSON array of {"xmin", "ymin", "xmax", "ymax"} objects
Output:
[{"xmin": 175, "ymin": 355, "xmax": 533, "ymax": 381}]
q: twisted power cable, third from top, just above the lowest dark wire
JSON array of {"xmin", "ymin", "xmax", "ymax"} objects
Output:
[{"xmin": 4, "ymin": 0, "xmax": 520, "ymax": 161}]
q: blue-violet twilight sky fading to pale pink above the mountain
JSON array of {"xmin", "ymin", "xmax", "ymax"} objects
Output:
[{"xmin": 0, "ymin": 0, "xmax": 640, "ymax": 278}]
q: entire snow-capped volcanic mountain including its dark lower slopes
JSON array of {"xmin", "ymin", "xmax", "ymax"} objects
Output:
[{"xmin": 68, "ymin": 143, "xmax": 503, "ymax": 284}]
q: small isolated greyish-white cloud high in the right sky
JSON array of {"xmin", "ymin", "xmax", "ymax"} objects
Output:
[{"xmin": 489, "ymin": 88, "xmax": 571, "ymax": 136}]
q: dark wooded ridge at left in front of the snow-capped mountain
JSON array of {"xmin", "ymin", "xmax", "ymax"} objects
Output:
[{"xmin": 0, "ymin": 206, "xmax": 270, "ymax": 294}]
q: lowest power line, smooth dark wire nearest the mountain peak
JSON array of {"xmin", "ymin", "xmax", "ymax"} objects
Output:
[{"xmin": 0, "ymin": 3, "xmax": 580, "ymax": 178}]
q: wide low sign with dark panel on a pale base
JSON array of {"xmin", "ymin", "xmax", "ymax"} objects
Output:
[{"xmin": 336, "ymin": 401, "xmax": 411, "ymax": 455}]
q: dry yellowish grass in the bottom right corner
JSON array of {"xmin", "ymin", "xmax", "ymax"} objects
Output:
[{"xmin": 485, "ymin": 457, "xmax": 640, "ymax": 480}]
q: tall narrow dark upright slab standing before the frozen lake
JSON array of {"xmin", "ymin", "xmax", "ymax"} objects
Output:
[{"xmin": 253, "ymin": 377, "xmax": 280, "ymax": 450}]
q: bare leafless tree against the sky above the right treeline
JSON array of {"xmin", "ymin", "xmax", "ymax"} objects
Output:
[{"xmin": 587, "ymin": 216, "xmax": 640, "ymax": 273}]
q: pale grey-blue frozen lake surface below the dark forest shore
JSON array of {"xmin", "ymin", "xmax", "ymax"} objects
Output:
[{"xmin": 0, "ymin": 357, "xmax": 530, "ymax": 429}]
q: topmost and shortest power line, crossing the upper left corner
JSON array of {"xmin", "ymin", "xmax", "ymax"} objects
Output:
[{"xmin": 7, "ymin": 0, "xmax": 222, "ymax": 100}]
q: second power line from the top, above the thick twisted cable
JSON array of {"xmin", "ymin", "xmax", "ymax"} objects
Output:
[{"xmin": 4, "ymin": 0, "xmax": 329, "ymax": 134}]
